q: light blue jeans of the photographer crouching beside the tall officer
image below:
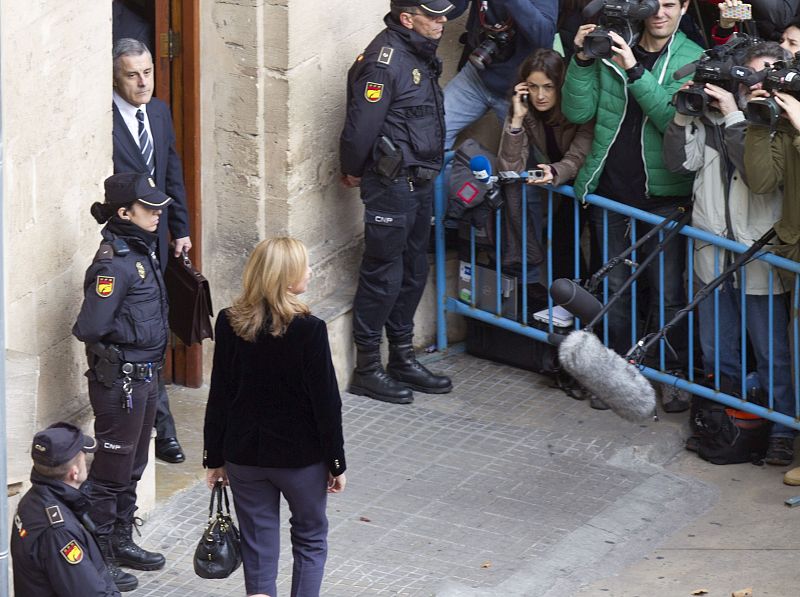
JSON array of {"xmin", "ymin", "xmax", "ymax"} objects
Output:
[{"xmin": 444, "ymin": 62, "xmax": 509, "ymax": 149}]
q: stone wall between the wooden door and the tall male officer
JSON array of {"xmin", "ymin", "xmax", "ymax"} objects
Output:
[{"xmin": 201, "ymin": 0, "xmax": 476, "ymax": 385}]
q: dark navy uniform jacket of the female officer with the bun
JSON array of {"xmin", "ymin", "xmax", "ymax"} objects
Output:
[{"xmin": 72, "ymin": 221, "xmax": 169, "ymax": 365}]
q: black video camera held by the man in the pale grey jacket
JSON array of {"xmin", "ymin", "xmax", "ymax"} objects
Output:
[{"xmin": 673, "ymin": 34, "xmax": 764, "ymax": 116}]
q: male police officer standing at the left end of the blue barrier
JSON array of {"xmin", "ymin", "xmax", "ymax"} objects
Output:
[{"xmin": 340, "ymin": 0, "xmax": 453, "ymax": 404}]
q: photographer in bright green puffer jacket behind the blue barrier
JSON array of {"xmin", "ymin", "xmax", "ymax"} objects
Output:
[{"xmin": 561, "ymin": 0, "xmax": 702, "ymax": 412}]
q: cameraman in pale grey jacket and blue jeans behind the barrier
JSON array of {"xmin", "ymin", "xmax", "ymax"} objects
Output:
[{"xmin": 664, "ymin": 38, "xmax": 794, "ymax": 465}]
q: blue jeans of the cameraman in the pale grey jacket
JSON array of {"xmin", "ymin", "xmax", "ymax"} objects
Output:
[{"xmin": 697, "ymin": 281, "xmax": 795, "ymax": 437}]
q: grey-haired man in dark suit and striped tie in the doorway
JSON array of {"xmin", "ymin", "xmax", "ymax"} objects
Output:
[{"xmin": 113, "ymin": 38, "xmax": 192, "ymax": 463}]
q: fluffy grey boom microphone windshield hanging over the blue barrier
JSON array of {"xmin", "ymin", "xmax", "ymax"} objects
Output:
[{"xmin": 558, "ymin": 330, "xmax": 656, "ymax": 423}]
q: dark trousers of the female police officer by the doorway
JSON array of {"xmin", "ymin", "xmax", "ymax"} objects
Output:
[{"xmin": 87, "ymin": 371, "xmax": 158, "ymax": 535}]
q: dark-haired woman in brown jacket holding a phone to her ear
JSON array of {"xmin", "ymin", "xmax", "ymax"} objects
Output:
[{"xmin": 497, "ymin": 48, "xmax": 594, "ymax": 283}]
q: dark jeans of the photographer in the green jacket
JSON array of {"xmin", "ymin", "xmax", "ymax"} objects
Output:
[{"xmin": 589, "ymin": 204, "xmax": 688, "ymax": 371}]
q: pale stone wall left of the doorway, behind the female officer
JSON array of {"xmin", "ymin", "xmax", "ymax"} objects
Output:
[{"xmin": 0, "ymin": 0, "xmax": 112, "ymax": 482}]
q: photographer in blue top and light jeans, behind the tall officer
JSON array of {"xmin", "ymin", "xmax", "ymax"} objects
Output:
[{"xmin": 444, "ymin": 0, "xmax": 558, "ymax": 149}]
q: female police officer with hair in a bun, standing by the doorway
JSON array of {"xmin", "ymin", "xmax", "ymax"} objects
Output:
[{"xmin": 72, "ymin": 173, "xmax": 172, "ymax": 591}]
